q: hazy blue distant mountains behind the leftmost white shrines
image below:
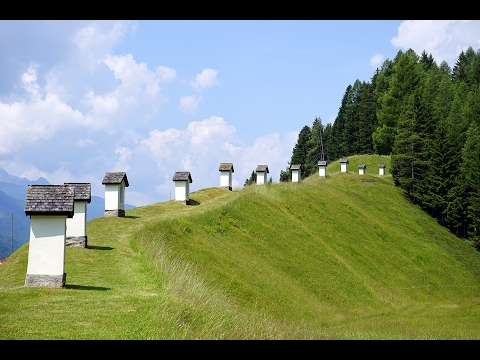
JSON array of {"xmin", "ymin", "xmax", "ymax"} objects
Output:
[{"xmin": 0, "ymin": 168, "xmax": 135, "ymax": 259}]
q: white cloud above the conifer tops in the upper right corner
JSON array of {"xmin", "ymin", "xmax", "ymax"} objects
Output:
[{"xmin": 391, "ymin": 20, "xmax": 480, "ymax": 67}]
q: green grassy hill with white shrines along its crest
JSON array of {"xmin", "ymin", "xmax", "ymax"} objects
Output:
[{"xmin": 0, "ymin": 155, "xmax": 480, "ymax": 339}]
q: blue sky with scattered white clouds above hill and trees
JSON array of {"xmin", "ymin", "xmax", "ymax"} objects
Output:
[{"xmin": 0, "ymin": 20, "xmax": 480, "ymax": 206}]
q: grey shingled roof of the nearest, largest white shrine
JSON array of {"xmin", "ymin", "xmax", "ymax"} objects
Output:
[{"xmin": 25, "ymin": 185, "xmax": 75, "ymax": 217}]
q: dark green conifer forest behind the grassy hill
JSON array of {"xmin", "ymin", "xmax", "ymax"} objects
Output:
[{"xmin": 280, "ymin": 46, "xmax": 480, "ymax": 248}]
